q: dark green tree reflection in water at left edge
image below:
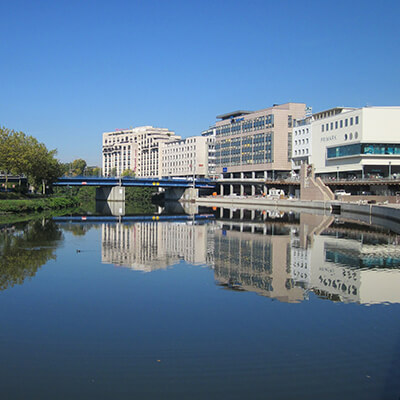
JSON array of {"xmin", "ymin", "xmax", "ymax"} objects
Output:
[{"xmin": 0, "ymin": 220, "xmax": 62, "ymax": 290}]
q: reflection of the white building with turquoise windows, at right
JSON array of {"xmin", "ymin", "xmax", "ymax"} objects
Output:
[{"xmin": 291, "ymin": 215, "xmax": 400, "ymax": 304}]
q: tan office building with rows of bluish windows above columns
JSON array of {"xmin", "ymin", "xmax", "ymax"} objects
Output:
[{"xmin": 206, "ymin": 103, "xmax": 306, "ymax": 178}]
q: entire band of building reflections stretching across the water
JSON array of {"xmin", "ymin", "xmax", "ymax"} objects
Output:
[{"xmin": 102, "ymin": 210, "xmax": 400, "ymax": 304}]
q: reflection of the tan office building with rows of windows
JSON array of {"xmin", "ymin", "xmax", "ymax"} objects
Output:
[{"xmin": 214, "ymin": 222, "xmax": 303, "ymax": 302}]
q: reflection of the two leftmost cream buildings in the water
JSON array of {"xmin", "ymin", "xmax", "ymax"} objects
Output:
[{"xmin": 102, "ymin": 222, "xmax": 212, "ymax": 272}]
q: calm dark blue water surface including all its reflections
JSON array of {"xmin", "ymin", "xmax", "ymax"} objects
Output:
[{"xmin": 0, "ymin": 210, "xmax": 400, "ymax": 400}]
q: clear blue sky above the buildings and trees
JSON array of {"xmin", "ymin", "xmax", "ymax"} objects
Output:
[{"xmin": 0, "ymin": 0, "xmax": 400, "ymax": 165}]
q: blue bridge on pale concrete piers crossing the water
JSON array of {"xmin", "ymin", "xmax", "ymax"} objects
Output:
[{"xmin": 53, "ymin": 176, "xmax": 216, "ymax": 201}]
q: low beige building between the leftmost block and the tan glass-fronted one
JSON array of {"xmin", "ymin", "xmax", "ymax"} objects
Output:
[{"xmin": 160, "ymin": 136, "xmax": 215, "ymax": 178}]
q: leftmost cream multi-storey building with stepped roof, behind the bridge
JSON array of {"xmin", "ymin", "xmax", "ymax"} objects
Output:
[{"xmin": 103, "ymin": 126, "xmax": 180, "ymax": 177}]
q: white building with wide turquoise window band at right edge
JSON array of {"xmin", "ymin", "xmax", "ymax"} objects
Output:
[{"xmin": 310, "ymin": 107, "xmax": 400, "ymax": 178}]
